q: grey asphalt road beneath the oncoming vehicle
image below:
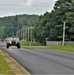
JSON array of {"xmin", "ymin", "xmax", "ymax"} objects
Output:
[{"xmin": 0, "ymin": 42, "xmax": 74, "ymax": 75}]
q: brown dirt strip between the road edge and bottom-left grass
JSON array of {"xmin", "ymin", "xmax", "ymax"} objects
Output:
[{"xmin": 0, "ymin": 50, "xmax": 31, "ymax": 75}]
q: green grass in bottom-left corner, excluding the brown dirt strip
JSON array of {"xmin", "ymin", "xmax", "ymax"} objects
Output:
[{"xmin": 0, "ymin": 51, "xmax": 14, "ymax": 75}]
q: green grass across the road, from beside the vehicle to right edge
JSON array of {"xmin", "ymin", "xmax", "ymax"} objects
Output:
[{"xmin": 21, "ymin": 41, "xmax": 74, "ymax": 52}]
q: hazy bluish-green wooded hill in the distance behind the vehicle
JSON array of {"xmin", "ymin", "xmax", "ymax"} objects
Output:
[{"xmin": 0, "ymin": 14, "xmax": 39, "ymax": 38}]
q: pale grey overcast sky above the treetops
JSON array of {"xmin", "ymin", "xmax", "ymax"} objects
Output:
[{"xmin": 0, "ymin": 0, "xmax": 56, "ymax": 17}]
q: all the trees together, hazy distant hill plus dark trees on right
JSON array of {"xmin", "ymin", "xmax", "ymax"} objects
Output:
[{"xmin": 0, "ymin": 0, "xmax": 74, "ymax": 43}]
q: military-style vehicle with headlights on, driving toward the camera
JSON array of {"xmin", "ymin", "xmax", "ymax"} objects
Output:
[{"xmin": 6, "ymin": 37, "xmax": 20, "ymax": 48}]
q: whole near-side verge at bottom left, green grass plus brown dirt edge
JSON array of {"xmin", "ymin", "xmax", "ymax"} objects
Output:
[{"xmin": 0, "ymin": 49, "xmax": 31, "ymax": 75}]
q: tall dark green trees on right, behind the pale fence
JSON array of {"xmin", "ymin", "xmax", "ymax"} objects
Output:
[{"xmin": 34, "ymin": 0, "xmax": 74, "ymax": 42}]
